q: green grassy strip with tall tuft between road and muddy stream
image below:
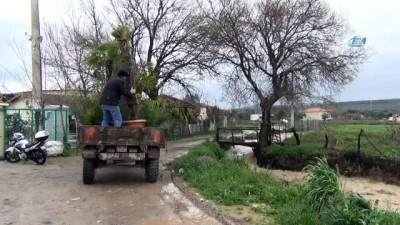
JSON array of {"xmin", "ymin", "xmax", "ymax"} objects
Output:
[{"xmin": 174, "ymin": 141, "xmax": 400, "ymax": 225}]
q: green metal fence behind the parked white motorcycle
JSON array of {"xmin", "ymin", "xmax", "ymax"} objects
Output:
[{"xmin": 0, "ymin": 108, "xmax": 70, "ymax": 147}]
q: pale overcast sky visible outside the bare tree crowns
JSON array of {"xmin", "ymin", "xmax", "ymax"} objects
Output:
[{"xmin": 0, "ymin": 0, "xmax": 400, "ymax": 107}]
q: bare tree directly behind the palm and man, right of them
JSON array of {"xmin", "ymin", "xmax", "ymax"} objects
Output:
[{"xmin": 111, "ymin": 0, "xmax": 211, "ymax": 99}]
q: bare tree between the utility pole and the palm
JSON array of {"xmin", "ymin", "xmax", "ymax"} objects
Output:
[{"xmin": 43, "ymin": 0, "xmax": 108, "ymax": 97}]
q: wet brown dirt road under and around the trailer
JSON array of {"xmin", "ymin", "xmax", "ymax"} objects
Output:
[{"xmin": 0, "ymin": 136, "xmax": 220, "ymax": 225}]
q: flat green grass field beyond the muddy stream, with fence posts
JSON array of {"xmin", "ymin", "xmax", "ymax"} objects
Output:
[{"xmin": 266, "ymin": 123, "xmax": 400, "ymax": 160}]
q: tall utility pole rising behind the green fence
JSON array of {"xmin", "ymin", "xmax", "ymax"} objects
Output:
[{"xmin": 31, "ymin": 0, "xmax": 43, "ymax": 108}]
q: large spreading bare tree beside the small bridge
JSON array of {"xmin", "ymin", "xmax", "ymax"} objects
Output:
[{"xmin": 199, "ymin": 0, "xmax": 366, "ymax": 147}]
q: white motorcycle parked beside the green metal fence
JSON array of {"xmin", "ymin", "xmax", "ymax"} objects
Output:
[{"xmin": 4, "ymin": 131, "xmax": 49, "ymax": 165}]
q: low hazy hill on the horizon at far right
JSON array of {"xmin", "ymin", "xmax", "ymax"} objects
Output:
[{"xmin": 338, "ymin": 98, "xmax": 400, "ymax": 111}]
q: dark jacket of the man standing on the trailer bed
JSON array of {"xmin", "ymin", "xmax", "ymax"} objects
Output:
[{"xmin": 100, "ymin": 76, "xmax": 133, "ymax": 106}]
